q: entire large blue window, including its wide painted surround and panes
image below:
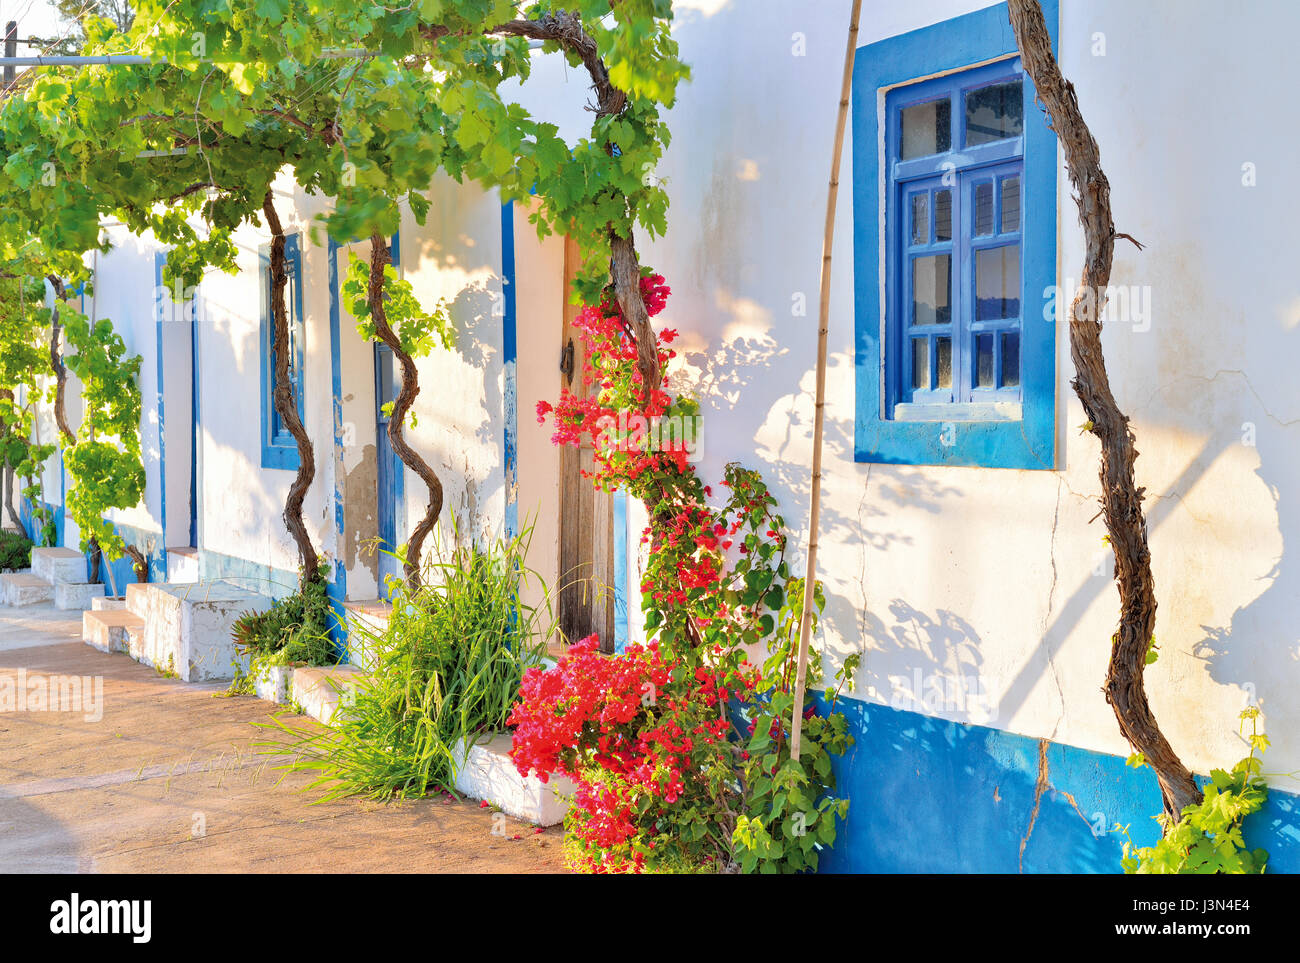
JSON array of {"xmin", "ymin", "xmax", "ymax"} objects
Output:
[{"xmin": 853, "ymin": 0, "xmax": 1057, "ymax": 468}]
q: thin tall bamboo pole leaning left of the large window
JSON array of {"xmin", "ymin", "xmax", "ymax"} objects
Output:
[{"xmin": 790, "ymin": 0, "xmax": 862, "ymax": 762}]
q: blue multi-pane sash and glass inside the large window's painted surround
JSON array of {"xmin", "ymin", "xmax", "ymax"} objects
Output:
[{"xmin": 885, "ymin": 60, "xmax": 1024, "ymax": 420}]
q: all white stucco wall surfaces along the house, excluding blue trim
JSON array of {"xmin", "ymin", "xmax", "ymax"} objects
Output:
[{"xmin": 25, "ymin": 0, "xmax": 1300, "ymax": 791}]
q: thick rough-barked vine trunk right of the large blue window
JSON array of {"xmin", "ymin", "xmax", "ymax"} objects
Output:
[{"xmin": 1008, "ymin": 0, "xmax": 1201, "ymax": 821}]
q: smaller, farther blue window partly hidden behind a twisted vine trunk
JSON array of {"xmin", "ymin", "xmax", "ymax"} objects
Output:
[{"xmin": 257, "ymin": 234, "xmax": 307, "ymax": 472}]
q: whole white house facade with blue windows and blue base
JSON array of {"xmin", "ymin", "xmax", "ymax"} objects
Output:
[{"xmin": 12, "ymin": 0, "xmax": 1300, "ymax": 872}]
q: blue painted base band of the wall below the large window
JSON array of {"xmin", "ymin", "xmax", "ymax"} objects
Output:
[{"xmin": 816, "ymin": 697, "xmax": 1300, "ymax": 873}]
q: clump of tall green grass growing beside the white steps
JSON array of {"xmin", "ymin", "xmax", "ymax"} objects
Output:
[{"xmin": 264, "ymin": 514, "xmax": 555, "ymax": 801}]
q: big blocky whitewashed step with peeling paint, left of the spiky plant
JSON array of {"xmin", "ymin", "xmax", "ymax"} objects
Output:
[{"xmin": 126, "ymin": 581, "xmax": 270, "ymax": 682}]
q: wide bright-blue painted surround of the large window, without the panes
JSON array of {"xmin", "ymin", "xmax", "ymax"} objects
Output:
[{"xmin": 853, "ymin": 0, "xmax": 1060, "ymax": 469}]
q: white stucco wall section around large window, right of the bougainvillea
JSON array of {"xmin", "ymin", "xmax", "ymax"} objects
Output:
[{"xmin": 574, "ymin": 0, "xmax": 1300, "ymax": 790}]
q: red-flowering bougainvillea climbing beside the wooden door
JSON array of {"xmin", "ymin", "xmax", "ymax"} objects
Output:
[{"xmin": 510, "ymin": 276, "xmax": 855, "ymax": 872}]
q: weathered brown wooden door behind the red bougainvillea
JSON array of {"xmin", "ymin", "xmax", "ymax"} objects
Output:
[{"xmin": 556, "ymin": 239, "xmax": 615, "ymax": 652}]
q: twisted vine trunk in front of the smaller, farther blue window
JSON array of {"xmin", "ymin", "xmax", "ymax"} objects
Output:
[{"xmin": 261, "ymin": 187, "xmax": 321, "ymax": 586}]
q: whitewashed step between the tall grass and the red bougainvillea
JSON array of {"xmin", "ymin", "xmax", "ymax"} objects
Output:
[{"xmin": 455, "ymin": 733, "xmax": 576, "ymax": 827}]
